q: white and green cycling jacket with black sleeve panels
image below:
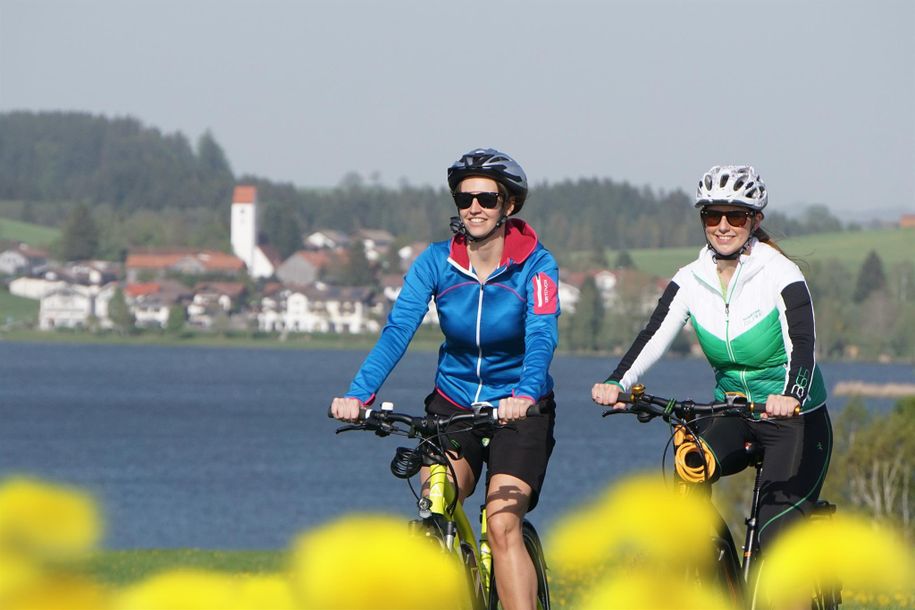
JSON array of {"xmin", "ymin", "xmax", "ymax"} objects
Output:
[{"xmin": 607, "ymin": 238, "xmax": 826, "ymax": 411}]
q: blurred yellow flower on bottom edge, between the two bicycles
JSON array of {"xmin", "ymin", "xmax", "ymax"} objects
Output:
[{"xmin": 575, "ymin": 571, "xmax": 737, "ymax": 610}]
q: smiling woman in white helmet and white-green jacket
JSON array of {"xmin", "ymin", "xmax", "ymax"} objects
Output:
[{"xmin": 591, "ymin": 165, "xmax": 832, "ymax": 547}]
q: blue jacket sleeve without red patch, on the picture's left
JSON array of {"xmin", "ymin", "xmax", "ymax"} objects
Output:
[{"xmin": 346, "ymin": 248, "xmax": 437, "ymax": 404}]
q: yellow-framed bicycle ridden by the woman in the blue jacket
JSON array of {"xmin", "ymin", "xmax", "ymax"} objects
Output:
[{"xmin": 328, "ymin": 403, "xmax": 550, "ymax": 610}]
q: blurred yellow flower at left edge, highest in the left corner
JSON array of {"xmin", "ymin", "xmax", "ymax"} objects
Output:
[{"xmin": 0, "ymin": 478, "xmax": 101, "ymax": 558}]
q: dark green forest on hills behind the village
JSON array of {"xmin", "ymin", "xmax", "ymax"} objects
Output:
[{"xmin": 0, "ymin": 112, "xmax": 842, "ymax": 258}]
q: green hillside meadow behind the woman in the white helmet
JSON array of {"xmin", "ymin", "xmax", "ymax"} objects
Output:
[{"xmin": 607, "ymin": 228, "xmax": 915, "ymax": 278}]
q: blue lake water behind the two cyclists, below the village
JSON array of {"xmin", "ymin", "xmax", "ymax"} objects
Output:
[{"xmin": 0, "ymin": 342, "xmax": 913, "ymax": 549}]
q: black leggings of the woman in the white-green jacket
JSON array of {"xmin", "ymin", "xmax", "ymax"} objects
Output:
[{"xmin": 699, "ymin": 405, "xmax": 832, "ymax": 549}]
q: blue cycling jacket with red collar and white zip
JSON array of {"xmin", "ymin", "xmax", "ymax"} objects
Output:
[{"xmin": 346, "ymin": 219, "xmax": 559, "ymax": 408}]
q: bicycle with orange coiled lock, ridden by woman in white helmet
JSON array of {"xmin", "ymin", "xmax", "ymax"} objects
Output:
[{"xmin": 603, "ymin": 384, "xmax": 842, "ymax": 610}]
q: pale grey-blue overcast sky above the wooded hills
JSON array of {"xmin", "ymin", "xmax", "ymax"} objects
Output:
[{"xmin": 0, "ymin": 0, "xmax": 915, "ymax": 217}]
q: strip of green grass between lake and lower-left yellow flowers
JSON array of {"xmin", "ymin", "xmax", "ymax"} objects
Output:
[{"xmin": 83, "ymin": 549, "xmax": 288, "ymax": 586}]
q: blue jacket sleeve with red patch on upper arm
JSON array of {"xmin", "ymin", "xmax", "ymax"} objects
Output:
[{"xmin": 512, "ymin": 250, "xmax": 559, "ymax": 401}]
